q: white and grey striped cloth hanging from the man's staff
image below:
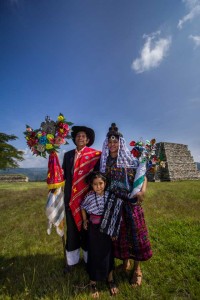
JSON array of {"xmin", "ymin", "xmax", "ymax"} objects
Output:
[{"xmin": 46, "ymin": 187, "xmax": 65, "ymax": 237}]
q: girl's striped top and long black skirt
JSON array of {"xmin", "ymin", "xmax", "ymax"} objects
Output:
[{"xmin": 81, "ymin": 191, "xmax": 114, "ymax": 281}]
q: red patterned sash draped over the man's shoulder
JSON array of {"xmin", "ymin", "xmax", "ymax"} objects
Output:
[{"xmin": 69, "ymin": 147, "xmax": 101, "ymax": 231}]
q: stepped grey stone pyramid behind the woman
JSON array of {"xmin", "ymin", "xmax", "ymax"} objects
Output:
[{"xmin": 149, "ymin": 142, "xmax": 200, "ymax": 181}]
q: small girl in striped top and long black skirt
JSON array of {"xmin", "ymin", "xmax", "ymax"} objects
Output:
[{"xmin": 81, "ymin": 172, "xmax": 118, "ymax": 298}]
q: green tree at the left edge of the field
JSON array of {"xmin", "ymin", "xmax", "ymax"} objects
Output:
[{"xmin": 0, "ymin": 132, "xmax": 24, "ymax": 169}]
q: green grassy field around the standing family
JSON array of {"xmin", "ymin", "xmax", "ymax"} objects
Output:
[{"xmin": 0, "ymin": 181, "xmax": 200, "ymax": 300}]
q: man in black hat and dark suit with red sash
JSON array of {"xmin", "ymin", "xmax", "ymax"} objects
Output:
[{"xmin": 62, "ymin": 126, "xmax": 101, "ymax": 266}]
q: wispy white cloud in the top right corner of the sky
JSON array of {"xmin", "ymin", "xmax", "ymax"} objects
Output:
[{"xmin": 177, "ymin": 0, "xmax": 200, "ymax": 29}]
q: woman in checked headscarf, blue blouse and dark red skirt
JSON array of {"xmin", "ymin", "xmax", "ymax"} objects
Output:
[{"xmin": 100, "ymin": 123, "xmax": 152, "ymax": 287}]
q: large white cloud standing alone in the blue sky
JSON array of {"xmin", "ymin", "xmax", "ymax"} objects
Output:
[{"xmin": 131, "ymin": 31, "xmax": 171, "ymax": 73}]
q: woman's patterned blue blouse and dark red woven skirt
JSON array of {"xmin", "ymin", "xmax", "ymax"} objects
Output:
[{"xmin": 106, "ymin": 156, "xmax": 152, "ymax": 261}]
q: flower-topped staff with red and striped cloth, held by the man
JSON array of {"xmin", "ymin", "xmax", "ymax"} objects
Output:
[{"xmin": 24, "ymin": 113, "xmax": 73, "ymax": 266}]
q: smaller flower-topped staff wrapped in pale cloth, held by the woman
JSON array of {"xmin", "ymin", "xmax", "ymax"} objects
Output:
[{"xmin": 129, "ymin": 139, "xmax": 159, "ymax": 198}]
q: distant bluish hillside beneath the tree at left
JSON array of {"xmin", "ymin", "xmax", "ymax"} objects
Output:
[{"xmin": 0, "ymin": 168, "xmax": 47, "ymax": 181}]
